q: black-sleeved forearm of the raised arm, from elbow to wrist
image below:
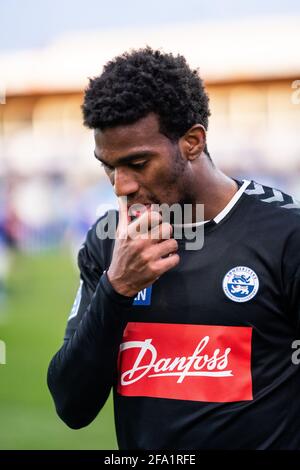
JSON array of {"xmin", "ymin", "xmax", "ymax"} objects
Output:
[{"xmin": 48, "ymin": 274, "xmax": 133, "ymax": 428}]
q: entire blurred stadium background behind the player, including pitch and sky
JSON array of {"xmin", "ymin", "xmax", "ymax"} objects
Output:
[{"xmin": 0, "ymin": 0, "xmax": 300, "ymax": 449}]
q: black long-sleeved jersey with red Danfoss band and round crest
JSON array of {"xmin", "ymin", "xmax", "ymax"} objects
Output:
[{"xmin": 48, "ymin": 181, "xmax": 300, "ymax": 450}]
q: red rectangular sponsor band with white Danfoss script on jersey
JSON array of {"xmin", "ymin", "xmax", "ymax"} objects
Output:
[{"xmin": 118, "ymin": 323, "xmax": 253, "ymax": 402}]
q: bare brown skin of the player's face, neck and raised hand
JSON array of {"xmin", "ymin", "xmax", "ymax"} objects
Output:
[{"xmin": 95, "ymin": 113, "xmax": 237, "ymax": 296}]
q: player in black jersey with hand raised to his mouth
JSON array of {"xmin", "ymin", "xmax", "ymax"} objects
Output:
[{"xmin": 48, "ymin": 48, "xmax": 300, "ymax": 450}]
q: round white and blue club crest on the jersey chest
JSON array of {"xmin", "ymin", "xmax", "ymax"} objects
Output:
[{"xmin": 223, "ymin": 266, "xmax": 259, "ymax": 302}]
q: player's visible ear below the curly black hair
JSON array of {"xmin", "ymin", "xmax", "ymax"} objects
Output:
[{"xmin": 179, "ymin": 124, "xmax": 206, "ymax": 161}]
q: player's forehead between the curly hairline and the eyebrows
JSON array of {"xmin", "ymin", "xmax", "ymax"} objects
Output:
[{"xmin": 95, "ymin": 113, "xmax": 170, "ymax": 157}]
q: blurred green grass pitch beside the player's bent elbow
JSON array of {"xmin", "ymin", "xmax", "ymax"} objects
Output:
[{"xmin": 0, "ymin": 252, "xmax": 117, "ymax": 449}]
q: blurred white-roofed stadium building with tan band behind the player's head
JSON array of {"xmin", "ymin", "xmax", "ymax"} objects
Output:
[{"xmin": 0, "ymin": 17, "xmax": 300, "ymax": 246}]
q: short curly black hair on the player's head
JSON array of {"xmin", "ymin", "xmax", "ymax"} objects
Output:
[{"xmin": 82, "ymin": 47, "xmax": 210, "ymax": 156}]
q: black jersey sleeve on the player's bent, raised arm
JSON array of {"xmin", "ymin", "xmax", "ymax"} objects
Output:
[{"xmin": 47, "ymin": 217, "xmax": 133, "ymax": 429}]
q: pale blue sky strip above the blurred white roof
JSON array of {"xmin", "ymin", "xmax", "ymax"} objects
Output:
[{"xmin": 0, "ymin": 0, "xmax": 300, "ymax": 51}]
